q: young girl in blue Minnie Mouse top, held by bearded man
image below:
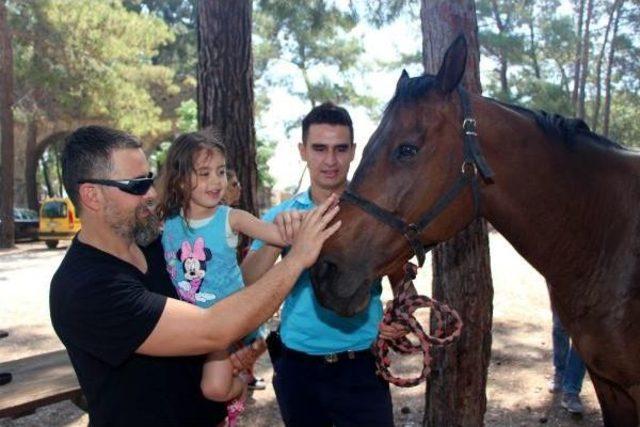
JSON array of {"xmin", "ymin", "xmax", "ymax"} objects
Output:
[{"xmin": 158, "ymin": 132, "xmax": 287, "ymax": 419}]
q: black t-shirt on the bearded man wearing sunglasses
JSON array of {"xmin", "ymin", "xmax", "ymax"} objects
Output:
[{"xmin": 49, "ymin": 238, "xmax": 226, "ymax": 427}]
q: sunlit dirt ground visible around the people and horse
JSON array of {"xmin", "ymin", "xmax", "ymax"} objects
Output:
[{"xmin": 0, "ymin": 234, "xmax": 602, "ymax": 427}]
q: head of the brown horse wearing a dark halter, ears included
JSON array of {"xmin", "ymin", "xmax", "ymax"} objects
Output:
[{"xmin": 311, "ymin": 37, "xmax": 490, "ymax": 316}]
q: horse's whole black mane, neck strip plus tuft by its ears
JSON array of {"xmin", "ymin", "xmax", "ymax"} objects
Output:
[{"xmin": 385, "ymin": 74, "xmax": 627, "ymax": 150}]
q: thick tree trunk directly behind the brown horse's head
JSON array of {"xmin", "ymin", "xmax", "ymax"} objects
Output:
[{"xmin": 420, "ymin": 0, "xmax": 493, "ymax": 427}]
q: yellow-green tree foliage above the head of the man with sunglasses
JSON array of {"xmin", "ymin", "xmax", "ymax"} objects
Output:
[{"xmin": 13, "ymin": 0, "xmax": 178, "ymax": 137}]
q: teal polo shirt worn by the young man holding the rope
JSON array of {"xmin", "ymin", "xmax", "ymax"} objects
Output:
[{"xmin": 251, "ymin": 190, "xmax": 382, "ymax": 355}]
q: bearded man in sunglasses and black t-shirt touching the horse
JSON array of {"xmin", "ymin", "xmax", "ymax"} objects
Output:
[{"xmin": 50, "ymin": 126, "xmax": 339, "ymax": 427}]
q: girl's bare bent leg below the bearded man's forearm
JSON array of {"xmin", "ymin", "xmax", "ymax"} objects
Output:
[{"xmin": 200, "ymin": 351, "xmax": 246, "ymax": 402}]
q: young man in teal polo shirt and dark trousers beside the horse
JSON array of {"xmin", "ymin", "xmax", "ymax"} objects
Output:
[{"xmin": 243, "ymin": 103, "xmax": 404, "ymax": 427}]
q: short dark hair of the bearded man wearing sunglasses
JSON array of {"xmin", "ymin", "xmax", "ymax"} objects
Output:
[{"xmin": 62, "ymin": 126, "xmax": 142, "ymax": 212}]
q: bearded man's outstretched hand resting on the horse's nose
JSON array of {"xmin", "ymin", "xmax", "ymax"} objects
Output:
[{"xmin": 285, "ymin": 194, "xmax": 342, "ymax": 268}]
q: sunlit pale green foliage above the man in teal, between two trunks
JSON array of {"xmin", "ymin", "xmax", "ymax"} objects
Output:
[{"xmin": 254, "ymin": 0, "xmax": 376, "ymax": 107}]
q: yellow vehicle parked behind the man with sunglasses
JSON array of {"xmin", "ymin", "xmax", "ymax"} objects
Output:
[{"xmin": 38, "ymin": 197, "xmax": 80, "ymax": 249}]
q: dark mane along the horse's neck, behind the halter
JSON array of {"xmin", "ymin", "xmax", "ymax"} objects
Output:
[{"xmin": 485, "ymin": 98, "xmax": 627, "ymax": 150}]
